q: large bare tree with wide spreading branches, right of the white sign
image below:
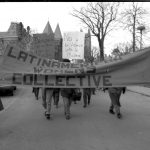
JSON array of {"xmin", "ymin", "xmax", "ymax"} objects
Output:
[{"xmin": 71, "ymin": 2, "xmax": 119, "ymax": 61}]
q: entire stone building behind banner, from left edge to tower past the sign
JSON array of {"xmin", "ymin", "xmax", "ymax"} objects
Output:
[{"xmin": 0, "ymin": 21, "xmax": 91, "ymax": 62}]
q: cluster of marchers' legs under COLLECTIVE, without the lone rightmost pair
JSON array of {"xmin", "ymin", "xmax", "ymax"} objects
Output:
[{"xmin": 32, "ymin": 87, "xmax": 93, "ymax": 120}]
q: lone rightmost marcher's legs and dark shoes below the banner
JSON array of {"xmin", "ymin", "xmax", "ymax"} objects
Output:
[{"xmin": 108, "ymin": 87, "xmax": 126, "ymax": 118}]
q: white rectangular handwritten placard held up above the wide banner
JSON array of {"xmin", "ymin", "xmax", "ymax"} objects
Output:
[{"xmin": 62, "ymin": 32, "xmax": 85, "ymax": 59}]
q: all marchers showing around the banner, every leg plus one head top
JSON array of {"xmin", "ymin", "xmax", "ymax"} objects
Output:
[{"xmin": 32, "ymin": 59, "xmax": 126, "ymax": 120}]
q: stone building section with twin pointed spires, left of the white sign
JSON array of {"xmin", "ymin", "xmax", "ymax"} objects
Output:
[{"xmin": 31, "ymin": 21, "xmax": 62, "ymax": 61}]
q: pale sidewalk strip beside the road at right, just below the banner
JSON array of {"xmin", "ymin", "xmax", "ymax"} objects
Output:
[{"xmin": 127, "ymin": 86, "xmax": 150, "ymax": 97}]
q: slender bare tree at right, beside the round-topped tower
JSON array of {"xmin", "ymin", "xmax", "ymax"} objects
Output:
[{"xmin": 121, "ymin": 2, "xmax": 147, "ymax": 52}]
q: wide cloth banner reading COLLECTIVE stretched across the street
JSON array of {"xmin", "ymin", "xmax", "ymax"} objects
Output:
[{"xmin": 0, "ymin": 46, "xmax": 150, "ymax": 88}]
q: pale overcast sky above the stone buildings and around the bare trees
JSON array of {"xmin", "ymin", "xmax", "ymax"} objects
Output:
[{"xmin": 0, "ymin": 2, "xmax": 150, "ymax": 54}]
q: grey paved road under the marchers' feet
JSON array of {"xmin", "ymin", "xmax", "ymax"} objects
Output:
[{"xmin": 0, "ymin": 88, "xmax": 150, "ymax": 150}]
